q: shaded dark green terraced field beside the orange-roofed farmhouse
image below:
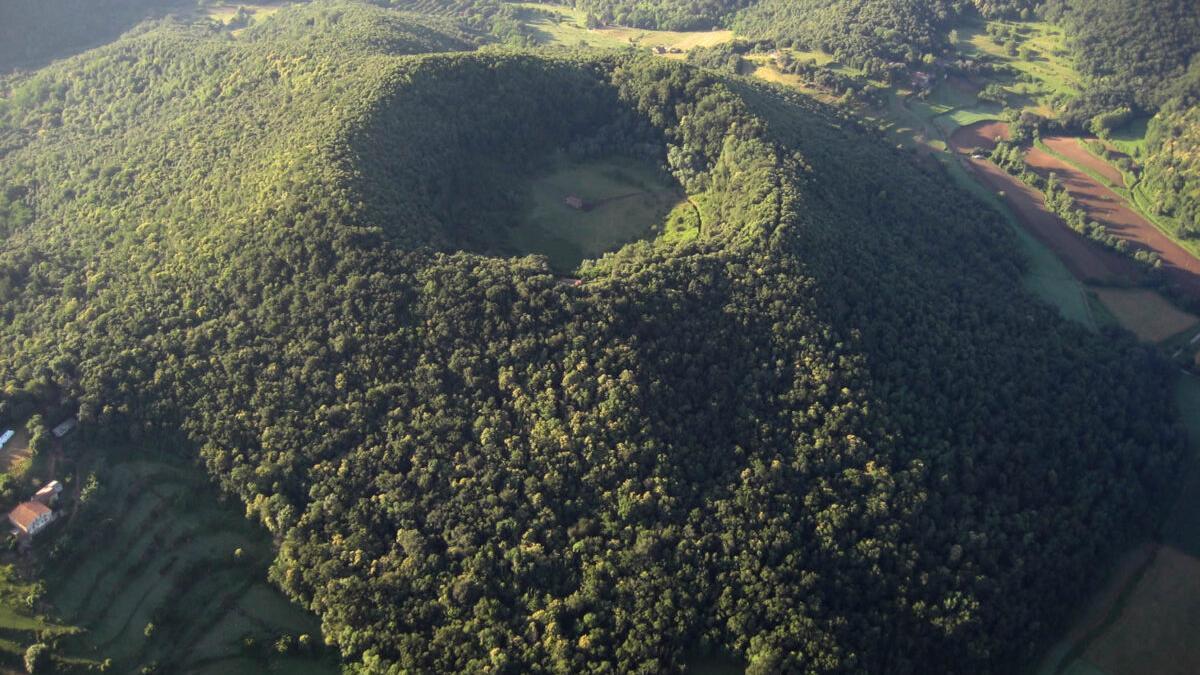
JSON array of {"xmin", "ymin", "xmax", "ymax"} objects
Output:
[{"xmin": 44, "ymin": 454, "xmax": 336, "ymax": 673}]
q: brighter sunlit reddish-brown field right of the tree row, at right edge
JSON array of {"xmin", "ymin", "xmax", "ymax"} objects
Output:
[{"xmin": 1025, "ymin": 148, "xmax": 1200, "ymax": 298}]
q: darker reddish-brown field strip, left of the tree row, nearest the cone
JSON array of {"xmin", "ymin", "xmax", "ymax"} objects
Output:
[{"xmin": 950, "ymin": 121, "xmax": 1141, "ymax": 282}]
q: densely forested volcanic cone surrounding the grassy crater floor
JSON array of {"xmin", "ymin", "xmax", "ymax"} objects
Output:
[{"xmin": 0, "ymin": 1, "xmax": 1182, "ymax": 673}]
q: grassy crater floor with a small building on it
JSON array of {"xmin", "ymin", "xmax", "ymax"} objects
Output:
[{"xmin": 508, "ymin": 157, "xmax": 690, "ymax": 273}]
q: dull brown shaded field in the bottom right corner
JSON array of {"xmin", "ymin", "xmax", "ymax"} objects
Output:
[{"xmin": 1084, "ymin": 546, "xmax": 1200, "ymax": 675}]
